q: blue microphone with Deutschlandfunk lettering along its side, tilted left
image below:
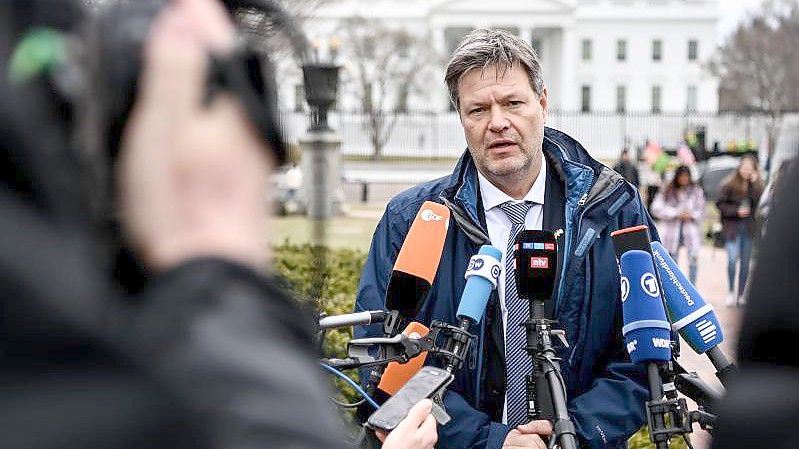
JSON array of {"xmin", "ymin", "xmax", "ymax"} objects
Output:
[{"xmin": 652, "ymin": 242, "xmax": 736, "ymax": 387}]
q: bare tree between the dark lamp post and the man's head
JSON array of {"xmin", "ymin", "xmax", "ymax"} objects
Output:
[{"xmin": 339, "ymin": 17, "xmax": 436, "ymax": 159}]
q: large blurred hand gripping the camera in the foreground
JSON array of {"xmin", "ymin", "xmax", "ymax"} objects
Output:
[{"xmin": 118, "ymin": 0, "xmax": 272, "ymax": 269}]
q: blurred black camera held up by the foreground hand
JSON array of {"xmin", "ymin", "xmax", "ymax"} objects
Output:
[{"xmin": 83, "ymin": 0, "xmax": 294, "ymax": 165}]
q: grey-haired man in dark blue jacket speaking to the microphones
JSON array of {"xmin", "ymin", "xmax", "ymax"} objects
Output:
[{"xmin": 355, "ymin": 30, "xmax": 657, "ymax": 449}]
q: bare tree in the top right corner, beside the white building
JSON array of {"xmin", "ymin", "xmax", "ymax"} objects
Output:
[{"xmin": 710, "ymin": 0, "xmax": 799, "ymax": 169}]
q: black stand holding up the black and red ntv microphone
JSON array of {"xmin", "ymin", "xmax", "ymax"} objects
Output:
[{"xmin": 522, "ymin": 299, "xmax": 578, "ymax": 449}]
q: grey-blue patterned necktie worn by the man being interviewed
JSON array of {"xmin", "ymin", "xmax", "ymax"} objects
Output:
[{"xmin": 499, "ymin": 201, "xmax": 533, "ymax": 427}]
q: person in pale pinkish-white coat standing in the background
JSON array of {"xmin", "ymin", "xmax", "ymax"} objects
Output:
[{"xmin": 651, "ymin": 165, "xmax": 705, "ymax": 284}]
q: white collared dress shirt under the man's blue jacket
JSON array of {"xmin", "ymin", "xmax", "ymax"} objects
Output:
[{"xmin": 477, "ymin": 157, "xmax": 547, "ymax": 422}]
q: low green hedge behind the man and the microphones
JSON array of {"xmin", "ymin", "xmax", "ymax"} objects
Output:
[{"xmin": 274, "ymin": 242, "xmax": 687, "ymax": 449}]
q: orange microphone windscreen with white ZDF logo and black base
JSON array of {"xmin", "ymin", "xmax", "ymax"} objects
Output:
[{"xmin": 386, "ymin": 201, "xmax": 450, "ymax": 329}]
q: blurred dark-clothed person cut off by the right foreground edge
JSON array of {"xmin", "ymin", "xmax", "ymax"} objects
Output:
[{"xmin": 713, "ymin": 154, "xmax": 799, "ymax": 449}]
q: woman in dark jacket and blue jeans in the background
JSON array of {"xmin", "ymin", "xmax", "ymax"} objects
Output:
[{"xmin": 716, "ymin": 155, "xmax": 763, "ymax": 307}]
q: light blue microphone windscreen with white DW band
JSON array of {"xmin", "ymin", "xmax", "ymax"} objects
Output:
[{"xmin": 457, "ymin": 245, "xmax": 502, "ymax": 323}]
